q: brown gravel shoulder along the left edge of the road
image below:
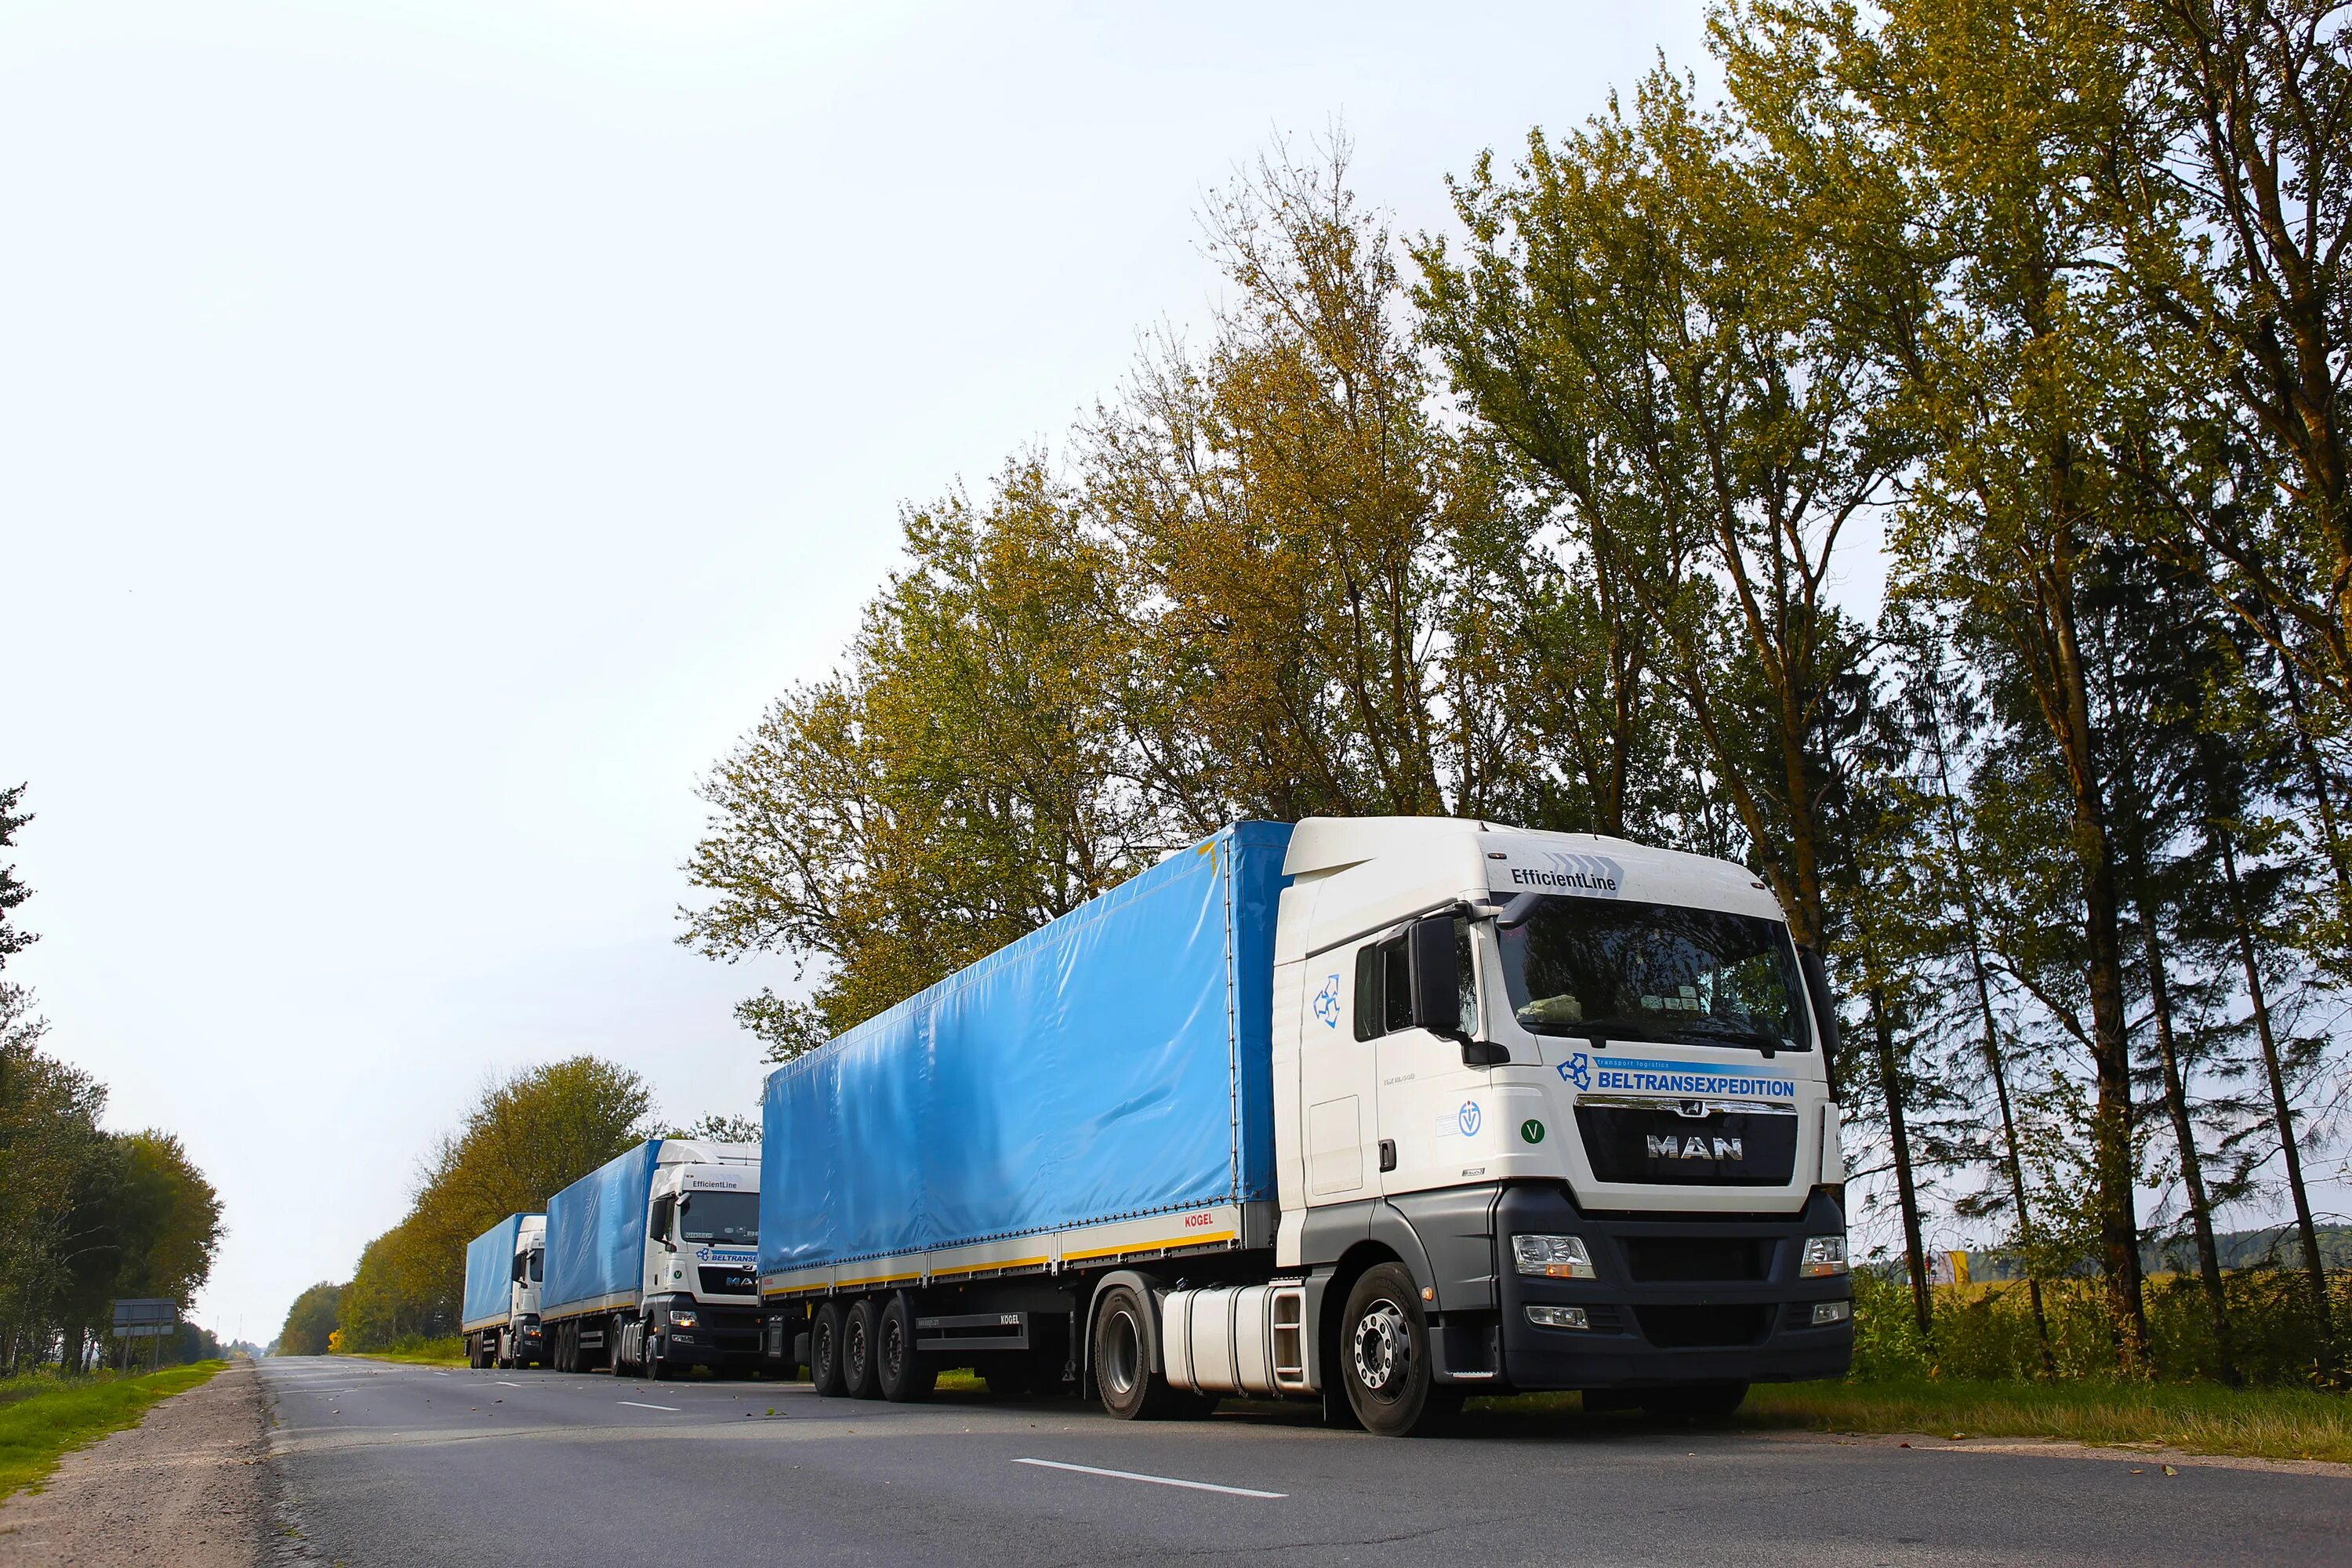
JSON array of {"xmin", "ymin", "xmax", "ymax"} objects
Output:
[{"xmin": 0, "ymin": 1361, "xmax": 270, "ymax": 1568}]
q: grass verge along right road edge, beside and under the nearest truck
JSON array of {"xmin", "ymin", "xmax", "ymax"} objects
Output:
[{"xmin": 1479, "ymin": 1377, "xmax": 2352, "ymax": 1465}]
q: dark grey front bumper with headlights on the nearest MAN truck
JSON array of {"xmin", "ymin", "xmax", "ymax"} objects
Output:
[{"xmin": 1486, "ymin": 1182, "xmax": 1853, "ymax": 1389}]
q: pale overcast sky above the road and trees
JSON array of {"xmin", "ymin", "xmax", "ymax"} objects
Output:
[{"xmin": 0, "ymin": 0, "xmax": 1759, "ymax": 1340}]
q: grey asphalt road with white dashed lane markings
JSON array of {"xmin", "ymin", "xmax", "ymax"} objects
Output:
[{"xmin": 261, "ymin": 1359, "xmax": 2352, "ymax": 1568}]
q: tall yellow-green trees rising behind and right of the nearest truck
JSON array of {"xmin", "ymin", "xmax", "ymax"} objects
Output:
[{"xmin": 682, "ymin": 0, "xmax": 2352, "ymax": 1382}]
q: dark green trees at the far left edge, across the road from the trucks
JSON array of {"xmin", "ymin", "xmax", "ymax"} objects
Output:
[{"xmin": 0, "ymin": 785, "xmax": 221, "ymax": 1375}]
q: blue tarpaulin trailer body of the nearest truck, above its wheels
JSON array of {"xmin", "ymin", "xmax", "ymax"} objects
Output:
[{"xmin": 760, "ymin": 822, "xmax": 1291, "ymax": 1300}]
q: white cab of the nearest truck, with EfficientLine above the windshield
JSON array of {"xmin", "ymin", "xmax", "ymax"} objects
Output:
[{"xmin": 1275, "ymin": 818, "xmax": 1851, "ymax": 1425}]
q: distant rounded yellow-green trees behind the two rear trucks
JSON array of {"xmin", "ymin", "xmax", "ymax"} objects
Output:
[{"xmin": 275, "ymin": 1055, "xmax": 760, "ymax": 1356}]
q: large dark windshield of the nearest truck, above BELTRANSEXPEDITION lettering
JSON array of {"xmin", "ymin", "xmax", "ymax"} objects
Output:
[{"xmin": 1496, "ymin": 895, "xmax": 1811, "ymax": 1051}]
